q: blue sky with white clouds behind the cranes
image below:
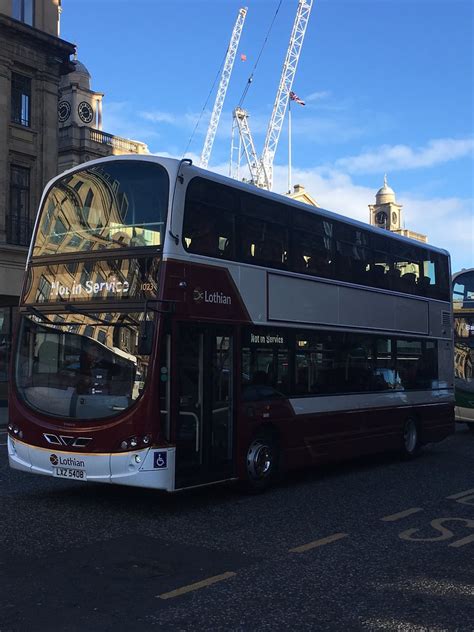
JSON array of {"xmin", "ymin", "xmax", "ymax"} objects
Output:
[{"xmin": 61, "ymin": 0, "xmax": 474, "ymax": 270}]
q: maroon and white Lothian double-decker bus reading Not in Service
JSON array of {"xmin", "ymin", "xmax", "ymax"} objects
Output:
[{"xmin": 8, "ymin": 156, "xmax": 454, "ymax": 492}]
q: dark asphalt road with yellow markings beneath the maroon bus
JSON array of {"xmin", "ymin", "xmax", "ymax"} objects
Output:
[{"xmin": 0, "ymin": 426, "xmax": 474, "ymax": 632}]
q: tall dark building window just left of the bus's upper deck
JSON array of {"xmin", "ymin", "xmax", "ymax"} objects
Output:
[{"xmin": 7, "ymin": 165, "xmax": 32, "ymax": 246}]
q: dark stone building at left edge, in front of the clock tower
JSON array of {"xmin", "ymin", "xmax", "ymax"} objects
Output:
[{"xmin": 0, "ymin": 0, "xmax": 75, "ymax": 405}]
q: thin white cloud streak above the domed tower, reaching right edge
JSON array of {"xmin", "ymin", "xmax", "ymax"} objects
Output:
[{"xmin": 336, "ymin": 138, "xmax": 474, "ymax": 173}]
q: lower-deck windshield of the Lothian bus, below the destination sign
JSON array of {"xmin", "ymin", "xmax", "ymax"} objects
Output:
[{"xmin": 15, "ymin": 309, "xmax": 152, "ymax": 420}]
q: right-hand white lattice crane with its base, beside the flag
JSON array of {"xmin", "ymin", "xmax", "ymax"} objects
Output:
[{"xmin": 231, "ymin": 0, "xmax": 313, "ymax": 191}]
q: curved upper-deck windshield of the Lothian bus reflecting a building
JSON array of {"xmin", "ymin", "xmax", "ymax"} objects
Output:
[{"xmin": 33, "ymin": 160, "xmax": 169, "ymax": 257}]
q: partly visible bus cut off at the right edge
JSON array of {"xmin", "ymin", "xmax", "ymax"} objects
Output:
[{"xmin": 453, "ymin": 268, "xmax": 474, "ymax": 432}]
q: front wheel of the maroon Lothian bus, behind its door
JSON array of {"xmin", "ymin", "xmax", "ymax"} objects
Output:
[{"xmin": 244, "ymin": 435, "xmax": 279, "ymax": 494}]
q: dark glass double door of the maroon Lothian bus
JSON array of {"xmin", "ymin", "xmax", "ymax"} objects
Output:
[{"xmin": 174, "ymin": 324, "xmax": 234, "ymax": 489}]
